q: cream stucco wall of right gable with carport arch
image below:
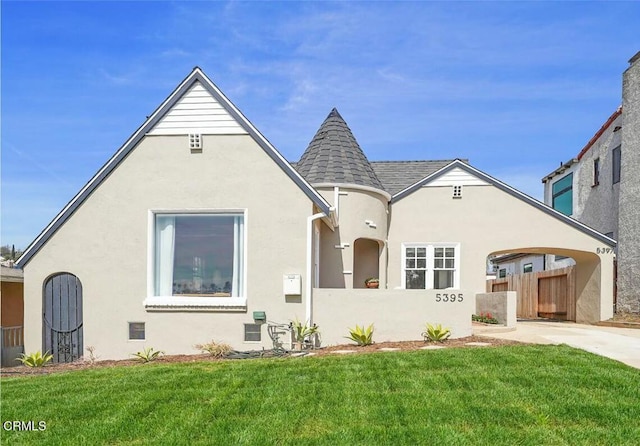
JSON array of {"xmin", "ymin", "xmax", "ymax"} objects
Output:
[{"xmin": 388, "ymin": 186, "xmax": 613, "ymax": 321}]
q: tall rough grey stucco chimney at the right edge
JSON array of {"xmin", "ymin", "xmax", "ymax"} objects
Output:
[{"xmin": 618, "ymin": 53, "xmax": 640, "ymax": 312}]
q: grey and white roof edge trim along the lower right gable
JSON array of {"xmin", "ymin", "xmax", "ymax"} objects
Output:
[{"xmin": 391, "ymin": 159, "xmax": 616, "ymax": 247}]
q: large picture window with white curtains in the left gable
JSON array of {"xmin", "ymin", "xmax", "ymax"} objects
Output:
[{"xmin": 154, "ymin": 214, "xmax": 244, "ymax": 297}]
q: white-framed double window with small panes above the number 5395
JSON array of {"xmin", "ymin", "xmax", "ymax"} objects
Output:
[{"xmin": 402, "ymin": 243, "xmax": 460, "ymax": 290}]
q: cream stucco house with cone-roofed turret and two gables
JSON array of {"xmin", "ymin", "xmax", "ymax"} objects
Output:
[{"xmin": 18, "ymin": 67, "xmax": 615, "ymax": 362}]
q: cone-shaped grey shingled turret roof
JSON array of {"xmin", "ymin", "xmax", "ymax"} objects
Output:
[{"xmin": 296, "ymin": 108, "xmax": 384, "ymax": 190}]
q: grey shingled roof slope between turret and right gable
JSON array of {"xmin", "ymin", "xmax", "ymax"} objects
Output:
[{"xmin": 371, "ymin": 160, "xmax": 466, "ymax": 195}]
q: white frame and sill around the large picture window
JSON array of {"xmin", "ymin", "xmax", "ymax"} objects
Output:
[{"xmin": 143, "ymin": 208, "xmax": 249, "ymax": 311}]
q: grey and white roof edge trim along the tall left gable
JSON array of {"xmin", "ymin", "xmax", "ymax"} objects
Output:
[{"xmin": 16, "ymin": 67, "xmax": 330, "ymax": 267}]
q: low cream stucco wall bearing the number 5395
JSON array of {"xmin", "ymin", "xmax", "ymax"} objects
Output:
[{"xmin": 313, "ymin": 289, "xmax": 475, "ymax": 345}]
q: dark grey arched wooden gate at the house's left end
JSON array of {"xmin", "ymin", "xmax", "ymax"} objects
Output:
[{"xmin": 42, "ymin": 273, "xmax": 83, "ymax": 362}]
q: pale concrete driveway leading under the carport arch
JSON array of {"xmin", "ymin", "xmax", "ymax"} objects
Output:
[{"xmin": 474, "ymin": 321, "xmax": 640, "ymax": 369}]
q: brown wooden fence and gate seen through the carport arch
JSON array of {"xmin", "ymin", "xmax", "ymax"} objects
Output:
[{"xmin": 487, "ymin": 266, "xmax": 576, "ymax": 321}]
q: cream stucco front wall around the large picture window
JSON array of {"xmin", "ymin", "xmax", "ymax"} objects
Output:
[{"xmin": 24, "ymin": 135, "xmax": 312, "ymax": 359}]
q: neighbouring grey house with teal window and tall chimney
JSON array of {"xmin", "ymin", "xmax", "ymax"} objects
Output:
[{"xmin": 542, "ymin": 52, "xmax": 640, "ymax": 313}]
